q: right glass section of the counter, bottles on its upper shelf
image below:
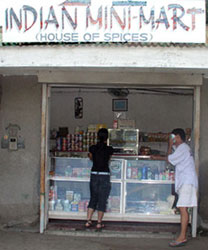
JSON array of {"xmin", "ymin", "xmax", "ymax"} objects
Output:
[{"xmin": 124, "ymin": 158, "xmax": 174, "ymax": 217}]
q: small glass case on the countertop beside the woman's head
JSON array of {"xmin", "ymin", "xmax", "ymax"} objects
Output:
[{"xmin": 108, "ymin": 129, "xmax": 139, "ymax": 155}]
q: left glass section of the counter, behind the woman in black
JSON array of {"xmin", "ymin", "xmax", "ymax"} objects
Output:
[{"xmin": 48, "ymin": 157, "xmax": 123, "ymax": 219}]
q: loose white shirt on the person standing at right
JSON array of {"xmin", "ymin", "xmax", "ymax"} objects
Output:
[{"xmin": 168, "ymin": 143, "xmax": 198, "ymax": 192}]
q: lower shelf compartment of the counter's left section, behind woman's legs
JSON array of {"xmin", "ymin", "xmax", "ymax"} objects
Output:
[{"xmin": 49, "ymin": 180, "xmax": 122, "ymax": 218}]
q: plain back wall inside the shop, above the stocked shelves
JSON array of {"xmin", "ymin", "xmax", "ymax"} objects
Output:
[{"xmin": 50, "ymin": 89, "xmax": 193, "ymax": 133}]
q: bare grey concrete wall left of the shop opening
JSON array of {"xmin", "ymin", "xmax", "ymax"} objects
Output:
[{"xmin": 0, "ymin": 77, "xmax": 41, "ymax": 223}]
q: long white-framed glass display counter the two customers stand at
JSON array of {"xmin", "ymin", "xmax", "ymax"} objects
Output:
[{"xmin": 48, "ymin": 155, "xmax": 180, "ymax": 223}]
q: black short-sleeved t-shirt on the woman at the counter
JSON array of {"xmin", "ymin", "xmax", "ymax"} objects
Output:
[{"xmin": 89, "ymin": 143, "xmax": 113, "ymax": 172}]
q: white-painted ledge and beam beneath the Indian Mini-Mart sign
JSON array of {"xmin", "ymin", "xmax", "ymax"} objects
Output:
[{"xmin": 0, "ymin": 44, "xmax": 208, "ymax": 85}]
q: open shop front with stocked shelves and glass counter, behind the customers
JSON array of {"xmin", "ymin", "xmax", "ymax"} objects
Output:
[{"xmin": 41, "ymin": 86, "xmax": 198, "ymax": 235}]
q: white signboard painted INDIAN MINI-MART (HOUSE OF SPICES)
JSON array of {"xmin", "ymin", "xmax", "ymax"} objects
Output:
[{"xmin": 0, "ymin": 0, "xmax": 206, "ymax": 43}]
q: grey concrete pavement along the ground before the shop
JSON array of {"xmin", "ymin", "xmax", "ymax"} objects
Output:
[{"xmin": 0, "ymin": 229, "xmax": 208, "ymax": 250}]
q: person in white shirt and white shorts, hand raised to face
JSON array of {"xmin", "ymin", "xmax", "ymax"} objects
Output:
[{"xmin": 152, "ymin": 128, "xmax": 198, "ymax": 247}]
